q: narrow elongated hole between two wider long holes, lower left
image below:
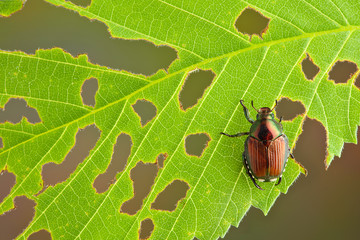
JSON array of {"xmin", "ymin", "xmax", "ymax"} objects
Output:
[{"xmin": 93, "ymin": 133, "xmax": 133, "ymax": 193}]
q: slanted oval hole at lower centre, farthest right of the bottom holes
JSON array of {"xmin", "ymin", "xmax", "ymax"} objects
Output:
[{"xmin": 151, "ymin": 179, "xmax": 190, "ymax": 211}]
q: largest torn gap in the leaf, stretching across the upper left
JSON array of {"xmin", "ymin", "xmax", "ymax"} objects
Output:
[{"xmin": 0, "ymin": 0, "xmax": 178, "ymax": 76}]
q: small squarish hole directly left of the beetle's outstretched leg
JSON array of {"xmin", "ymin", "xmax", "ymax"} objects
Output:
[{"xmin": 185, "ymin": 133, "xmax": 211, "ymax": 157}]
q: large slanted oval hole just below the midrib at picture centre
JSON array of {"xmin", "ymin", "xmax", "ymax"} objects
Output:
[{"xmin": 179, "ymin": 69, "xmax": 216, "ymax": 111}]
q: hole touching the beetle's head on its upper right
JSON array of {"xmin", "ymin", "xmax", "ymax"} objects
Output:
[{"xmin": 275, "ymin": 98, "xmax": 306, "ymax": 120}]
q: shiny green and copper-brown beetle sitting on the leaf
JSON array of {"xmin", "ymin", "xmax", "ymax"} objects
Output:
[{"xmin": 220, "ymin": 100, "xmax": 294, "ymax": 190}]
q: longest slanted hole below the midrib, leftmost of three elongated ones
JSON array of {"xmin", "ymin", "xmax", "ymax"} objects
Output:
[{"xmin": 38, "ymin": 124, "xmax": 101, "ymax": 194}]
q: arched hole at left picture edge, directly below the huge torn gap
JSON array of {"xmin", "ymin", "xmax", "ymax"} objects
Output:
[{"xmin": 0, "ymin": 98, "xmax": 41, "ymax": 124}]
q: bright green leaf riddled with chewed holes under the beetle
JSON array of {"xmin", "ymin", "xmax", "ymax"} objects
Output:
[{"xmin": 0, "ymin": 0, "xmax": 360, "ymax": 239}]
